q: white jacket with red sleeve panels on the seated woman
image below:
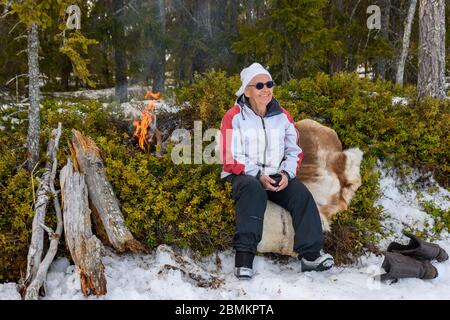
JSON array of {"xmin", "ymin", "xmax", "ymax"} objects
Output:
[{"xmin": 220, "ymin": 95, "xmax": 302, "ymax": 178}]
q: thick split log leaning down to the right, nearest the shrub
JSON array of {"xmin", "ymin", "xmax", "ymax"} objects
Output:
[{"xmin": 71, "ymin": 130, "xmax": 145, "ymax": 252}]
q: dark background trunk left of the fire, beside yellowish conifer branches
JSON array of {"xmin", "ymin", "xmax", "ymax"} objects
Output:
[{"xmin": 112, "ymin": 0, "xmax": 128, "ymax": 102}]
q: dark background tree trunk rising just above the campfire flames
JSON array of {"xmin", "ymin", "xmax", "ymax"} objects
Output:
[{"xmin": 152, "ymin": 0, "xmax": 166, "ymax": 92}]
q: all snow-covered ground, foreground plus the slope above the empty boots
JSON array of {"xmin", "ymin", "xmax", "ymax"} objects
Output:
[{"xmin": 0, "ymin": 170, "xmax": 450, "ymax": 300}]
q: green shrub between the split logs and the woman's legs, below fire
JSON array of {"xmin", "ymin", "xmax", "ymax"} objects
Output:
[{"xmin": 97, "ymin": 138, "xmax": 234, "ymax": 254}]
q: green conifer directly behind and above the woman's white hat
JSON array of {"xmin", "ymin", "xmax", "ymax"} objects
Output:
[{"xmin": 233, "ymin": 0, "xmax": 339, "ymax": 82}]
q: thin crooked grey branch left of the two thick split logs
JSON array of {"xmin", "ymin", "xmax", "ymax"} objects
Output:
[{"xmin": 25, "ymin": 123, "xmax": 63, "ymax": 300}]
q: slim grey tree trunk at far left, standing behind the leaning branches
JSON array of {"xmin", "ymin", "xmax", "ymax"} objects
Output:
[{"xmin": 27, "ymin": 23, "xmax": 41, "ymax": 172}]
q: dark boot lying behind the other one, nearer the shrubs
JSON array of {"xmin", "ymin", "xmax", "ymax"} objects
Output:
[{"xmin": 387, "ymin": 232, "xmax": 448, "ymax": 262}]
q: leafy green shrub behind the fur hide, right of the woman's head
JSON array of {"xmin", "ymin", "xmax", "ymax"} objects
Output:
[{"xmin": 275, "ymin": 73, "xmax": 450, "ymax": 187}]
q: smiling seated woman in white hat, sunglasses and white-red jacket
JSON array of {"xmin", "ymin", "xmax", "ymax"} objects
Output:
[{"xmin": 221, "ymin": 63, "xmax": 334, "ymax": 279}]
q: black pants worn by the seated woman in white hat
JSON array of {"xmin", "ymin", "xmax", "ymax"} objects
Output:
[{"xmin": 225, "ymin": 175, "xmax": 323, "ymax": 255}]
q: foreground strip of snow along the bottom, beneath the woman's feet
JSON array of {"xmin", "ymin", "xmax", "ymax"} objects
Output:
[{"xmin": 26, "ymin": 242, "xmax": 450, "ymax": 300}]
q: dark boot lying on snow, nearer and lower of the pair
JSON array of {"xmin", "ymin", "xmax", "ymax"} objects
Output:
[{"xmin": 381, "ymin": 252, "xmax": 438, "ymax": 281}]
